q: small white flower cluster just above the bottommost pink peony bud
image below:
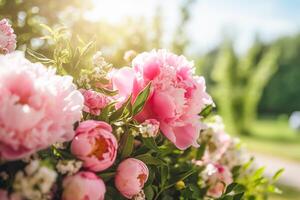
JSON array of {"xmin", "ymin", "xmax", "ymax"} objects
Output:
[{"xmin": 56, "ymin": 160, "xmax": 82, "ymax": 175}]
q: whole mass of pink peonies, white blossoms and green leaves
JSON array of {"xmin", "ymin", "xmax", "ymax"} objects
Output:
[{"xmin": 0, "ymin": 19, "xmax": 281, "ymax": 200}]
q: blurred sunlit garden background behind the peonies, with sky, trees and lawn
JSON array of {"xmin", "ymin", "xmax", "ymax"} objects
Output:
[{"xmin": 0, "ymin": 0, "xmax": 300, "ymax": 200}]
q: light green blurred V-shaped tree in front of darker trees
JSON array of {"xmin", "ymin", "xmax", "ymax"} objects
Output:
[{"xmin": 211, "ymin": 39, "xmax": 279, "ymax": 134}]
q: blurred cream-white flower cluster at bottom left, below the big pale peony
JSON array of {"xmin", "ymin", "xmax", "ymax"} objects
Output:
[{"xmin": 13, "ymin": 160, "xmax": 57, "ymax": 200}]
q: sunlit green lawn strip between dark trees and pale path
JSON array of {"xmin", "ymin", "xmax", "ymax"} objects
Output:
[{"xmin": 236, "ymin": 118, "xmax": 300, "ymax": 162}]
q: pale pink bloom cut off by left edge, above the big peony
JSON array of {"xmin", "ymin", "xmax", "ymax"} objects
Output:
[{"xmin": 0, "ymin": 19, "xmax": 17, "ymax": 54}]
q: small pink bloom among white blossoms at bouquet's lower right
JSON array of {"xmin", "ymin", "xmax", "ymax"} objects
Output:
[{"xmin": 207, "ymin": 164, "xmax": 233, "ymax": 198}]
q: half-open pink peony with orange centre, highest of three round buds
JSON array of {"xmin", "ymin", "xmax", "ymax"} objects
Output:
[{"xmin": 71, "ymin": 120, "xmax": 118, "ymax": 172}]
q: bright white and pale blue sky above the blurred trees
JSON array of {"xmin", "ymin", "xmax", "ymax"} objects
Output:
[{"xmin": 87, "ymin": 0, "xmax": 300, "ymax": 53}]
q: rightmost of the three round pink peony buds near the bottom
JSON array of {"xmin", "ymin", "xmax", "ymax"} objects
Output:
[{"xmin": 115, "ymin": 158, "xmax": 149, "ymax": 199}]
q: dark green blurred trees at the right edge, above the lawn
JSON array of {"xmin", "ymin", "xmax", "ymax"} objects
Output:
[{"xmin": 259, "ymin": 34, "xmax": 300, "ymax": 114}]
